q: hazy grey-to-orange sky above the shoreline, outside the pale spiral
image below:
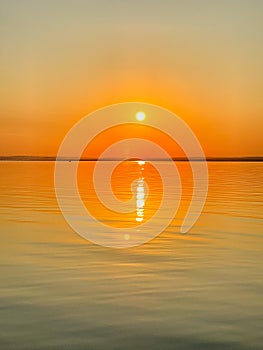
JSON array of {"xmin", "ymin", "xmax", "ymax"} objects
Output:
[{"xmin": 0, "ymin": 0, "xmax": 263, "ymax": 156}]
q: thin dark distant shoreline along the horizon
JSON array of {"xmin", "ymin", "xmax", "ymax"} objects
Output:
[{"xmin": 0, "ymin": 156, "xmax": 263, "ymax": 162}]
